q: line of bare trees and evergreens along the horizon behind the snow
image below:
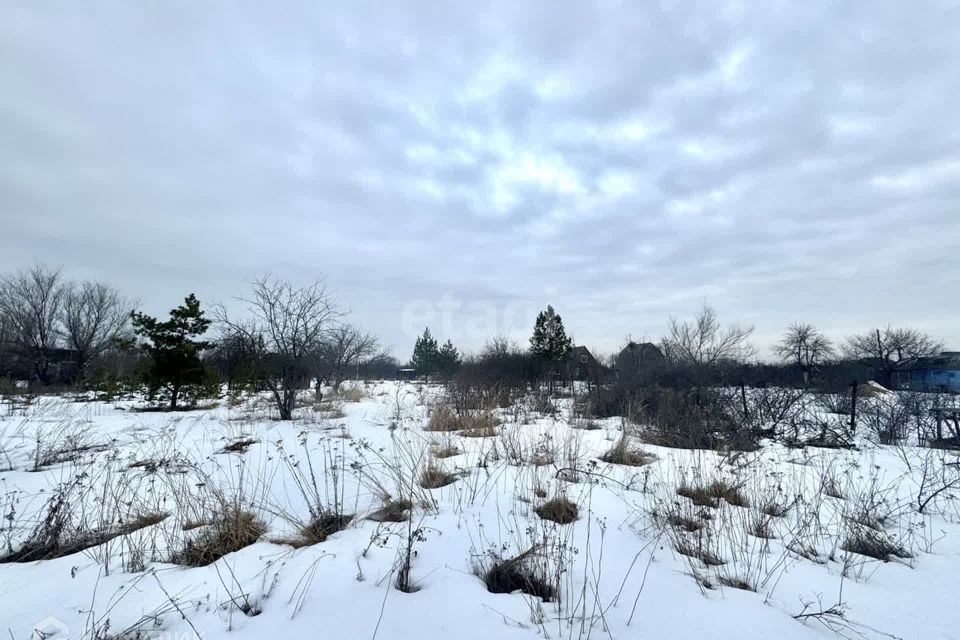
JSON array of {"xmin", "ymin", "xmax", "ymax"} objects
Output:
[{"xmin": 0, "ymin": 264, "xmax": 943, "ymax": 419}]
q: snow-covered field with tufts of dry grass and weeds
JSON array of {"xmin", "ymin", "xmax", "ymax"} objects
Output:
[{"xmin": 0, "ymin": 383, "xmax": 960, "ymax": 640}]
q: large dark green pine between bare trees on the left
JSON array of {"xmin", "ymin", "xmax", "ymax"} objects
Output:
[{"xmin": 130, "ymin": 293, "xmax": 210, "ymax": 410}]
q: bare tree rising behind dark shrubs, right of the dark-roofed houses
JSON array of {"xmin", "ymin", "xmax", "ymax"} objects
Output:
[{"xmin": 662, "ymin": 304, "xmax": 754, "ymax": 370}]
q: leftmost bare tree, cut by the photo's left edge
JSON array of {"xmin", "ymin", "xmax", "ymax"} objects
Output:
[{"xmin": 0, "ymin": 264, "xmax": 64, "ymax": 384}]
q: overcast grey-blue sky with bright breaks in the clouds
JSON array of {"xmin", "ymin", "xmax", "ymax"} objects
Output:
[{"xmin": 0, "ymin": 0, "xmax": 960, "ymax": 358}]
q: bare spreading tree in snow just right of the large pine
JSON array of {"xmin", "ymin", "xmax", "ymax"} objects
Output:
[{"xmin": 217, "ymin": 275, "xmax": 340, "ymax": 420}]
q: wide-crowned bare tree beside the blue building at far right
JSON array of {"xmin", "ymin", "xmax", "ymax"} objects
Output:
[{"xmin": 843, "ymin": 326, "xmax": 943, "ymax": 386}]
